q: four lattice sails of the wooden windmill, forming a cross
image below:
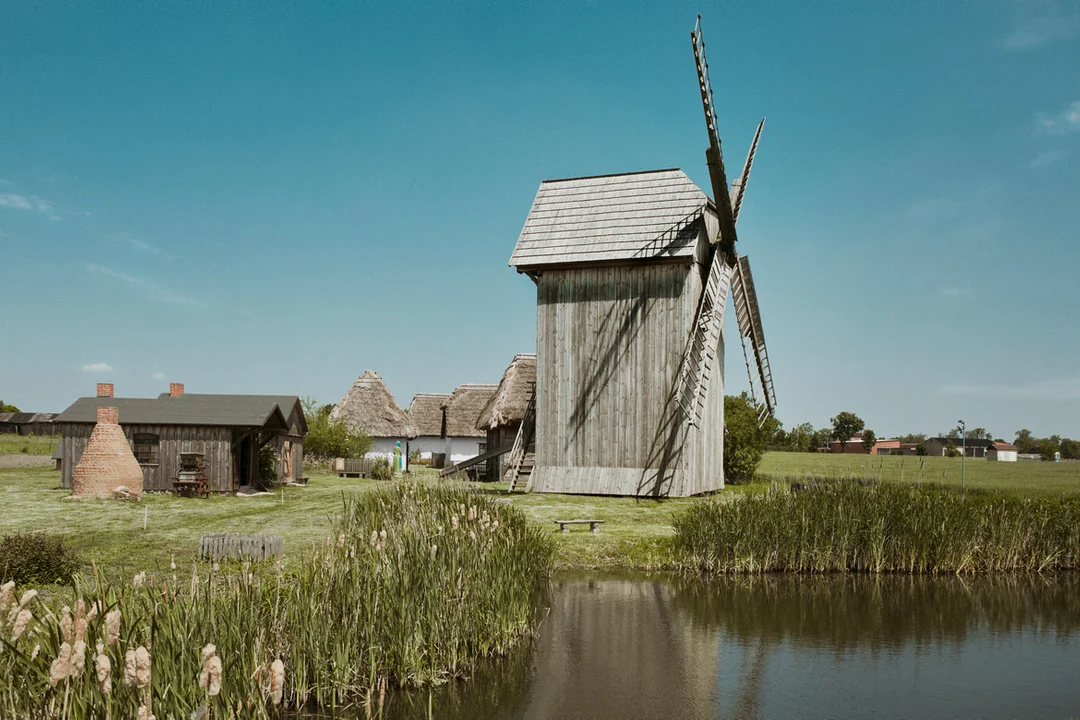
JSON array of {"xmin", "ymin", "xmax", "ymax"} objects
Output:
[{"xmin": 678, "ymin": 15, "xmax": 777, "ymax": 425}]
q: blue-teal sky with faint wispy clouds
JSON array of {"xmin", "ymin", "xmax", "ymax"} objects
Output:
[{"xmin": 0, "ymin": 0, "xmax": 1080, "ymax": 439}]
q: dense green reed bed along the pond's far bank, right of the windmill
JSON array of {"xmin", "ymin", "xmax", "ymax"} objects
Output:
[{"xmin": 673, "ymin": 478, "xmax": 1080, "ymax": 574}]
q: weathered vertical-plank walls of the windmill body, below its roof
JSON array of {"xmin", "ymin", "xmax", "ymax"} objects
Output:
[{"xmin": 534, "ymin": 263, "xmax": 724, "ymax": 495}]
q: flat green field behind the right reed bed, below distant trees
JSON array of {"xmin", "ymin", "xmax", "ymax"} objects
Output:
[{"xmin": 757, "ymin": 452, "xmax": 1080, "ymax": 495}]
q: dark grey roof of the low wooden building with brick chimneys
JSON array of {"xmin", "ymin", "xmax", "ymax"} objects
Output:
[{"xmin": 54, "ymin": 395, "xmax": 297, "ymax": 430}]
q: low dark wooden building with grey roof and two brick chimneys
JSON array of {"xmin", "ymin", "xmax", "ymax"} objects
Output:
[{"xmin": 53, "ymin": 382, "xmax": 308, "ymax": 492}]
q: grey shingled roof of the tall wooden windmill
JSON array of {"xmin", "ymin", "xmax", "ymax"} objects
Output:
[{"xmin": 510, "ymin": 168, "xmax": 714, "ymax": 270}]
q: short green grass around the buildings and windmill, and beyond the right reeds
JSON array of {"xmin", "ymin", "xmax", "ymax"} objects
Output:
[{"xmin": 0, "ymin": 452, "xmax": 1080, "ymax": 574}]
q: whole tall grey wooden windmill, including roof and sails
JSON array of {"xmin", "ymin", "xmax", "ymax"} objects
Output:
[{"xmin": 510, "ymin": 18, "xmax": 775, "ymax": 497}]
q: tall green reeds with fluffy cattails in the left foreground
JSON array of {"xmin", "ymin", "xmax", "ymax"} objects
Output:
[{"xmin": 0, "ymin": 484, "xmax": 553, "ymax": 720}]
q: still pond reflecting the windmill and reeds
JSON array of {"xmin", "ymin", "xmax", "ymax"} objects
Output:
[{"xmin": 317, "ymin": 574, "xmax": 1080, "ymax": 719}]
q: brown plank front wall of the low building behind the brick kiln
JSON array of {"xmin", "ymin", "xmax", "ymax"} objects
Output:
[{"xmin": 60, "ymin": 423, "xmax": 232, "ymax": 492}]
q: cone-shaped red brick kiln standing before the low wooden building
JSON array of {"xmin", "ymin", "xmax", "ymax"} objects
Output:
[{"xmin": 71, "ymin": 405, "xmax": 143, "ymax": 498}]
